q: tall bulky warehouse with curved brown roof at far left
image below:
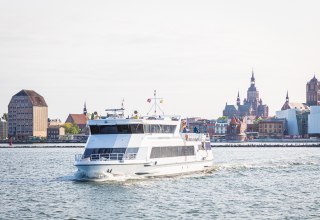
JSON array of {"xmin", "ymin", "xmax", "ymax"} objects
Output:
[{"xmin": 8, "ymin": 90, "xmax": 48, "ymax": 140}]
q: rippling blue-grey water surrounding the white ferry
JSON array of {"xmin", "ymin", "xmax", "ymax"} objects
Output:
[{"xmin": 0, "ymin": 148, "xmax": 320, "ymax": 219}]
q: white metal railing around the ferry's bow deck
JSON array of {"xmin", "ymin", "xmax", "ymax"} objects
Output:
[{"xmin": 75, "ymin": 153, "xmax": 137, "ymax": 161}]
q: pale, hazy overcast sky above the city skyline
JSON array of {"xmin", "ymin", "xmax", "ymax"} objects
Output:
[{"xmin": 0, "ymin": 0, "xmax": 320, "ymax": 120}]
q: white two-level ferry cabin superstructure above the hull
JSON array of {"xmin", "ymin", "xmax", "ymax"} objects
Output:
[{"xmin": 78, "ymin": 118, "xmax": 212, "ymax": 163}]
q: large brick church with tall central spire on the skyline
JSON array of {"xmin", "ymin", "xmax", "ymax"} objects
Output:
[{"xmin": 223, "ymin": 71, "xmax": 269, "ymax": 118}]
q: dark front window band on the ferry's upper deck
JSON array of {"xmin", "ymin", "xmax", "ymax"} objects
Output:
[{"xmin": 90, "ymin": 124, "xmax": 144, "ymax": 135}]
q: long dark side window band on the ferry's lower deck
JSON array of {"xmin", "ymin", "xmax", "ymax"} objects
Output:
[{"xmin": 150, "ymin": 146, "xmax": 194, "ymax": 158}]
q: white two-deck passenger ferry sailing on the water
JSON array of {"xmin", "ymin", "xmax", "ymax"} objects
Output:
[{"xmin": 75, "ymin": 97, "xmax": 213, "ymax": 178}]
